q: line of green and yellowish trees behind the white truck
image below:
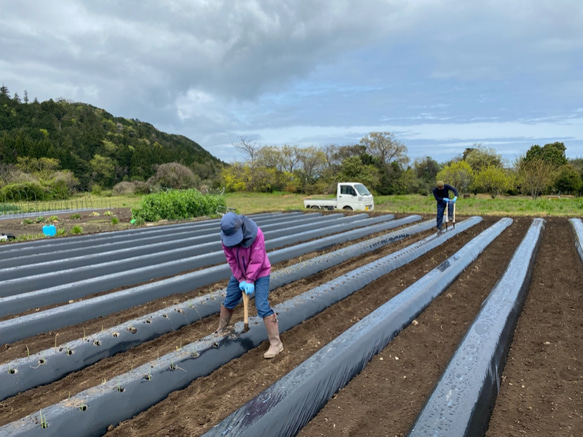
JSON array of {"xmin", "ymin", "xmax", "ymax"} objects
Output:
[{"xmin": 222, "ymin": 132, "xmax": 583, "ymax": 198}]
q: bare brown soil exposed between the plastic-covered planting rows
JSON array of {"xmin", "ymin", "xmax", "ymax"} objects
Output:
[{"xmin": 0, "ymin": 210, "xmax": 583, "ymax": 437}]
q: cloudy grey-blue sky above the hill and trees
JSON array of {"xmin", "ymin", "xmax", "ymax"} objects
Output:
[{"xmin": 0, "ymin": 0, "xmax": 583, "ymax": 162}]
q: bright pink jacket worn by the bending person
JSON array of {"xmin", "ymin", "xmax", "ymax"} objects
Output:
[{"xmin": 223, "ymin": 228, "xmax": 271, "ymax": 282}]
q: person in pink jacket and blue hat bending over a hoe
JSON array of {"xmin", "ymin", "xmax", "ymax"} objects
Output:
[{"xmin": 215, "ymin": 212, "xmax": 283, "ymax": 358}]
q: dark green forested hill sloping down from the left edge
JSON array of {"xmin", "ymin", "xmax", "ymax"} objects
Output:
[{"xmin": 0, "ymin": 86, "xmax": 224, "ymax": 189}]
